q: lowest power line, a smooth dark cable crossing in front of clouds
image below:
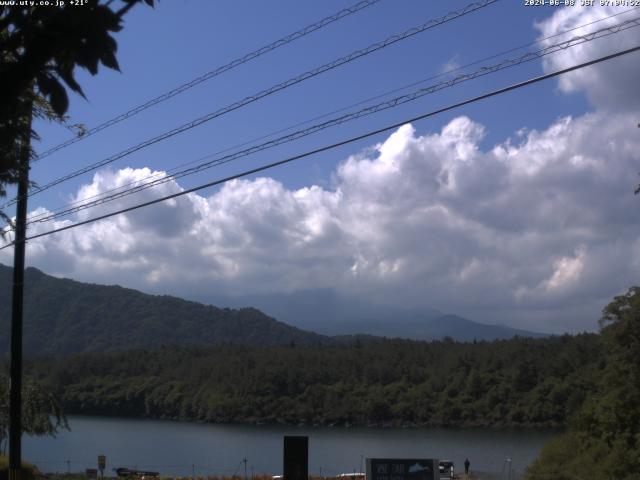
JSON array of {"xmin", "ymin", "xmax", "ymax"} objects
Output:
[{"xmin": 0, "ymin": 46, "xmax": 640, "ymax": 250}]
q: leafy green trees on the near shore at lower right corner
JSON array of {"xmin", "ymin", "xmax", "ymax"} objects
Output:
[{"xmin": 529, "ymin": 287, "xmax": 640, "ymax": 479}]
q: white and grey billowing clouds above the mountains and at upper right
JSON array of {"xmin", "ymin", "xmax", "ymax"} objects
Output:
[{"xmin": 0, "ymin": 4, "xmax": 640, "ymax": 332}]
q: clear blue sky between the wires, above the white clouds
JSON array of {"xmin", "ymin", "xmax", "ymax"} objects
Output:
[{"xmin": 28, "ymin": 0, "xmax": 586, "ymax": 197}]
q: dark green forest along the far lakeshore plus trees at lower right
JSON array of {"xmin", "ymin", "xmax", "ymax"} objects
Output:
[{"xmin": 0, "ymin": 287, "xmax": 640, "ymax": 480}]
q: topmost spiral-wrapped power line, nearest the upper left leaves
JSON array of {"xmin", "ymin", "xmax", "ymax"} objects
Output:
[{"xmin": 33, "ymin": 0, "xmax": 380, "ymax": 161}]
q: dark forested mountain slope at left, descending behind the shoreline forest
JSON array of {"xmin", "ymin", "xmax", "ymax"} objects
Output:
[{"xmin": 0, "ymin": 265, "xmax": 332, "ymax": 355}]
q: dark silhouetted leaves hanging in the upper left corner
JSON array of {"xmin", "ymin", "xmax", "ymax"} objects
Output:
[{"xmin": 0, "ymin": 0, "xmax": 154, "ymax": 196}]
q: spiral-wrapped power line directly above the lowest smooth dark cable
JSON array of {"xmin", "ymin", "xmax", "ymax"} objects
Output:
[{"xmin": 21, "ymin": 17, "xmax": 640, "ymax": 225}]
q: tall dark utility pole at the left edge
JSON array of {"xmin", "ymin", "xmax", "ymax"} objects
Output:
[{"xmin": 9, "ymin": 96, "xmax": 33, "ymax": 480}]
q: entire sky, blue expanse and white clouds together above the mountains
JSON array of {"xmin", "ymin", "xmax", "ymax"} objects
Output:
[{"xmin": 0, "ymin": 0, "xmax": 640, "ymax": 332}]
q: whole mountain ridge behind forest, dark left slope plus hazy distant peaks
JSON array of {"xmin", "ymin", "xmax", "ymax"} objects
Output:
[{"xmin": 0, "ymin": 264, "xmax": 544, "ymax": 356}]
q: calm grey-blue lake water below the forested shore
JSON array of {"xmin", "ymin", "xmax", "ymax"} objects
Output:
[{"xmin": 23, "ymin": 416, "xmax": 554, "ymax": 478}]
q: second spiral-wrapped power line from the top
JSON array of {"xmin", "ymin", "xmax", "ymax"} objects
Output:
[{"xmin": 0, "ymin": 0, "xmax": 499, "ymax": 209}]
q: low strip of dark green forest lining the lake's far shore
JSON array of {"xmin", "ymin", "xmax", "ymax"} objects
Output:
[{"xmin": 27, "ymin": 334, "xmax": 604, "ymax": 426}]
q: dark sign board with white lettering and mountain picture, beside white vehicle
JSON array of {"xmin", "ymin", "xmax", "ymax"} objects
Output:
[{"xmin": 367, "ymin": 458, "xmax": 440, "ymax": 480}]
